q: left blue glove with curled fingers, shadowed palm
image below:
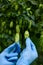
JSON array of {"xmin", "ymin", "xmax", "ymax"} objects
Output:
[{"xmin": 0, "ymin": 42, "xmax": 20, "ymax": 65}]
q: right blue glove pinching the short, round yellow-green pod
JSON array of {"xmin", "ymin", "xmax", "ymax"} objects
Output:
[{"xmin": 16, "ymin": 38, "xmax": 38, "ymax": 65}]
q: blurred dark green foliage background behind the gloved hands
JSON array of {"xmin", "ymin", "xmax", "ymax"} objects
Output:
[{"xmin": 0, "ymin": 0, "xmax": 43, "ymax": 65}]
